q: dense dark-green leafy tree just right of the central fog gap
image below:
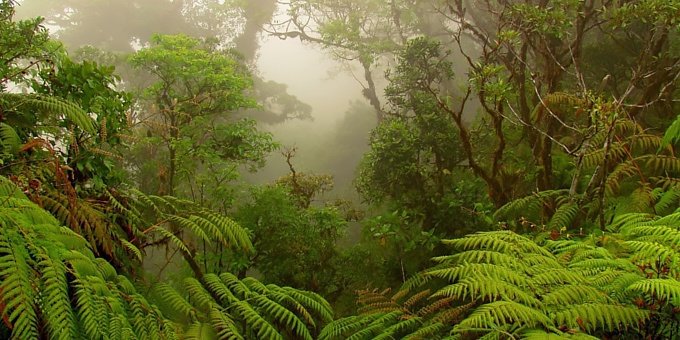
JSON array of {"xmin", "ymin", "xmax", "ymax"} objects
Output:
[{"xmin": 357, "ymin": 38, "xmax": 487, "ymax": 237}]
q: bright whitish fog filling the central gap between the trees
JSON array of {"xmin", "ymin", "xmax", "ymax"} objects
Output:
[{"xmin": 248, "ymin": 36, "xmax": 375, "ymax": 194}]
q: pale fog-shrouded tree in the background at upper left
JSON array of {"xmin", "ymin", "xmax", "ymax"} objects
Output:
[{"xmin": 15, "ymin": 0, "xmax": 311, "ymax": 124}]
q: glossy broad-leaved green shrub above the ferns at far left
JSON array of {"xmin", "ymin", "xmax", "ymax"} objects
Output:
[{"xmin": 32, "ymin": 56, "xmax": 132, "ymax": 191}]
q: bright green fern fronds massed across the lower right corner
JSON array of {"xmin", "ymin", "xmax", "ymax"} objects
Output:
[{"xmin": 321, "ymin": 213, "xmax": 680, "ymax": 339}]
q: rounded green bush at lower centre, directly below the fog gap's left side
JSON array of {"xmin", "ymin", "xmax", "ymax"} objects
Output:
[{"xmin": 236, "ymin": 186, "xmax": 347, "ymax": 294}]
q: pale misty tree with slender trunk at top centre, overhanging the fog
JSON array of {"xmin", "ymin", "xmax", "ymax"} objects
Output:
[{"xmin": 269, "ymin": 0, "xmax": 416, "ymax": 120}]
